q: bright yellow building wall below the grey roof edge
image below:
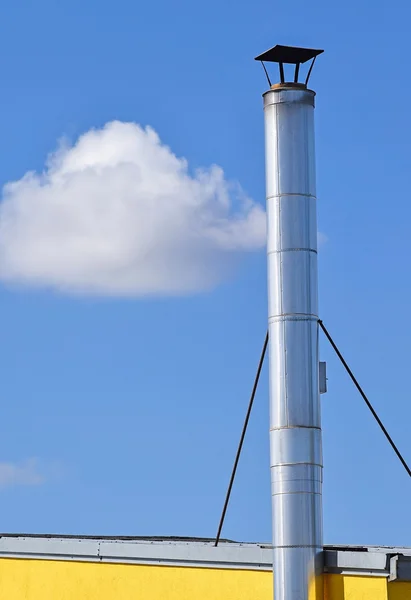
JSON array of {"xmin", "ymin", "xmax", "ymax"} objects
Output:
[{"xmin": 0, "ymin": 559, "xmax": 411, "ymax": 600}]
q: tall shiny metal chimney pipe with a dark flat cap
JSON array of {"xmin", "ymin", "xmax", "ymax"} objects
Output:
[{"xmin": 256, "ymin": 46, "xmax": 323, "ymax": 600}]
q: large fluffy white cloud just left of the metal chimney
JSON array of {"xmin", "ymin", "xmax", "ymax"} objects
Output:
[{"xmin": 0, "ymin": 122, "xmax": 266, "ymax": 296}]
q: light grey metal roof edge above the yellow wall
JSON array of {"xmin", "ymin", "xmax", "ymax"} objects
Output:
[{"xmin": 0, "ymin": 533, "xmax": 411, "ymax": 581}]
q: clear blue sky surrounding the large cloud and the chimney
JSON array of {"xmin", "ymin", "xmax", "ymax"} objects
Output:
[{"xmin": 0, "ymin": 0, "xmax": 411, "ymax": 545}]
